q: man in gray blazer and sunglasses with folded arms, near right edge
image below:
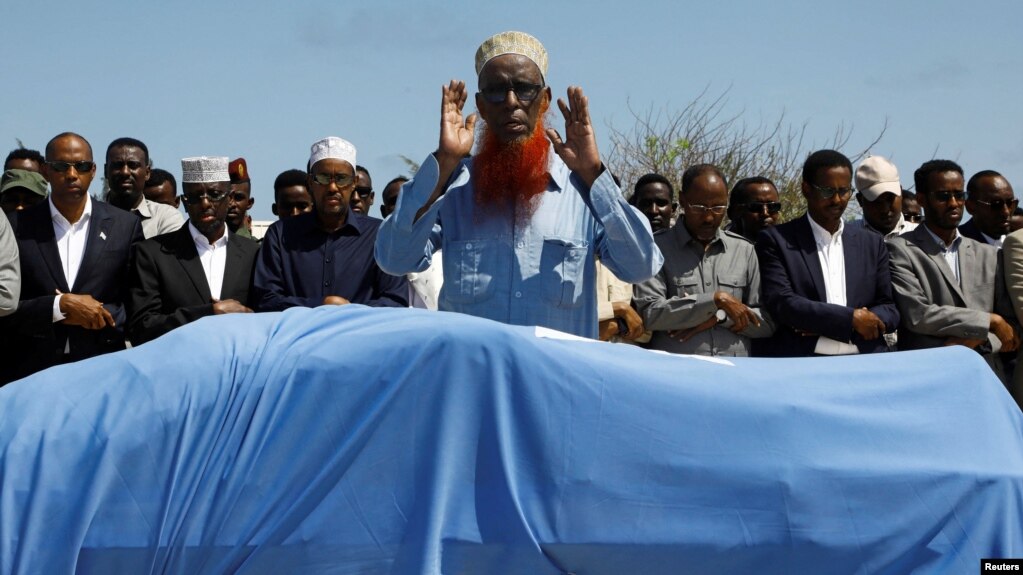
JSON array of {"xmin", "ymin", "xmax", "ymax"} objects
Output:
[{"xmin": 888, "ymin": 160, "xmax": 1019, "ymax": 382}]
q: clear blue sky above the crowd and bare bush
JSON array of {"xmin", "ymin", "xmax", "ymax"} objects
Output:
[{"xmin": 0, "ymin": 0, "xmax": 1023, "ymax": 219}]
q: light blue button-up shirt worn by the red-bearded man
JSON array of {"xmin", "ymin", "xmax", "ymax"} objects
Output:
[{"xmin": 376, "ymin": 151, "xmax": 664, "ymax": 338}]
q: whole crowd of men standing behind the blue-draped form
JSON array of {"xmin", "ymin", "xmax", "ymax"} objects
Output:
[{"xmin": 0, "ymin": 32, "xmax": 1023, "ymax": 407}]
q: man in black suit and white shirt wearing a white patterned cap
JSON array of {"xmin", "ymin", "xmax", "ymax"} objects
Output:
[{"xmin": 128, "ymin": 158, "xmax": 259, "ymax": 345}]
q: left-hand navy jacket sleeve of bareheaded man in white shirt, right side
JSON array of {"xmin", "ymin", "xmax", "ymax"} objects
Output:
[{"xmin": 755, "ymin": 225, "xmax": 853, "ymax": 342}]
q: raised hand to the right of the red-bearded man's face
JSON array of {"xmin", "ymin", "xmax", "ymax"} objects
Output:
[{"xmin": 547, "ymin": 86, "xmax": 602, "ymax": 186}]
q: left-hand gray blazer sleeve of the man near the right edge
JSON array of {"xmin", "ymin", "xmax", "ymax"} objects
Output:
[{"xmin": 888, "ymin": 237, "xmax": 991, "ymax": 339}]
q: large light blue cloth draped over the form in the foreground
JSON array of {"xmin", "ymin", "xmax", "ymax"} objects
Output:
[{"xmin": 0, "ymin": 305, "xmax": 1023, "ymax": 575}]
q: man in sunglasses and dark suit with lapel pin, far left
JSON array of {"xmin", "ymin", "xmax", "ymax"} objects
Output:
[{"xmin": 0, "ymin": 132, "xmax": 142, "ymax": 382}]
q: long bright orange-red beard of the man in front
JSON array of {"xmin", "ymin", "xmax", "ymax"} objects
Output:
[{"xmin": 473, "ymin": 118, "xmax": 550, "ymax": 224}]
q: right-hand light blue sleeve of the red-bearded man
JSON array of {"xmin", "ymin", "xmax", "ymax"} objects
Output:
[{"xmin": 585, "ymin": 169, "xmax": 664, "ymax": 283}]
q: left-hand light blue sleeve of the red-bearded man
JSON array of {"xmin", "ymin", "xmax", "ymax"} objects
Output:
[{"xmin": 374, "ymin": 154, "xmax": 443, "ymax": 276}]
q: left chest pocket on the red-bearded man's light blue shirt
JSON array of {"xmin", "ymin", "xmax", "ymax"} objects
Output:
[{"xmin": 444, "ymin": 239, "xmax": 499, "ymax": 304}]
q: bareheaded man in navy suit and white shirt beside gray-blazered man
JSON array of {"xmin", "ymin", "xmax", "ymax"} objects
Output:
[{"xmin": 753, "ymin": 149, "xmax": 899, "ymax": 357}]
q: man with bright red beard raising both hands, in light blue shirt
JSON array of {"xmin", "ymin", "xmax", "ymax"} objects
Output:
[{"xmin": 376, "ymin": 32, "xmax": 663, "ymax": 338}]
